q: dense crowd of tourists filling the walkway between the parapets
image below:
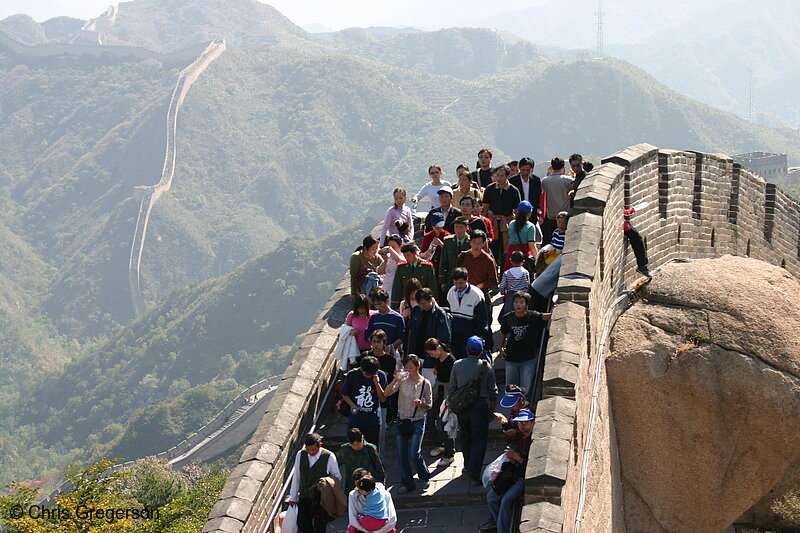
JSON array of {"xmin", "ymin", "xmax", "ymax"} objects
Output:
[{"xmin": 290, "ymin": 148, "xmax": 649, "ymax": 533}]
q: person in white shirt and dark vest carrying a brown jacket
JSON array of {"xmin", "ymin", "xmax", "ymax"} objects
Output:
[{"xmin": 289, "ymin": 433, "xmax": 342, "ymax": 533}]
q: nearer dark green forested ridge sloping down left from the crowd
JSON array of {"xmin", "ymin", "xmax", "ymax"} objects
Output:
[{"xmin": 0, "ymin": 220, "xmax": 376, "ymax": 481}]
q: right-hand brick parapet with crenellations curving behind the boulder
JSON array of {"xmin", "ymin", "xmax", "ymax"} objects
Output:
[{"xmin": 520, "ymin": 144, "xmax": 800, "ymax": 533}]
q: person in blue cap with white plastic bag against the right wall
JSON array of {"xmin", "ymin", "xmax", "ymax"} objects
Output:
[{"xmin": 480, "ymin": 409, "xmax": 536, "ymax": 533}]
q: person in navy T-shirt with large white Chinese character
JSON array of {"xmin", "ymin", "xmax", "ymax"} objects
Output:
[{"xmin": 342, "ymin": 356, "xmax": 387, "ymax": 444}]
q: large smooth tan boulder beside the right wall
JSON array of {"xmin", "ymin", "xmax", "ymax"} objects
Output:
[{"xmin": 606, "ymin": 256, "xmax": 800, "ymax": 533}]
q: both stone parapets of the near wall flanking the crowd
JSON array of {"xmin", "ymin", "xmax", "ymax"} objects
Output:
[{"xmin": 203, "ymin": 144, "xmax": 800, "ymax": 533}]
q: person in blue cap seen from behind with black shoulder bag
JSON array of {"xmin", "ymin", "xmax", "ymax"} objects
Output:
[{"xmin": 448, "ymin": 335, "xmax": 497, "ymax": 484}]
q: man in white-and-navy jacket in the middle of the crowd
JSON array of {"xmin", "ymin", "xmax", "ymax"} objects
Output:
[{"xmin": 447, "ymin": 267, "xmax": 489, "ymax": 359}]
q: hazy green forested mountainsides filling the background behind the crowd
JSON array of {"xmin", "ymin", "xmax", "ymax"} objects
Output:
[{"xmin": 0, "ymin": 0, "xmax": 800, "ymax": 494}]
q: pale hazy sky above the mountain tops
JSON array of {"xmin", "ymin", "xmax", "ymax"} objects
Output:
[{"xmin": 0, "ymin": 0, "xmax": 729, "ymax": 48}]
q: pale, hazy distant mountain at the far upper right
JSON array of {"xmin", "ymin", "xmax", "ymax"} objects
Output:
[{"xmin": 607, "ymin": 0, "xmax": 800, "ymax": 128}]
